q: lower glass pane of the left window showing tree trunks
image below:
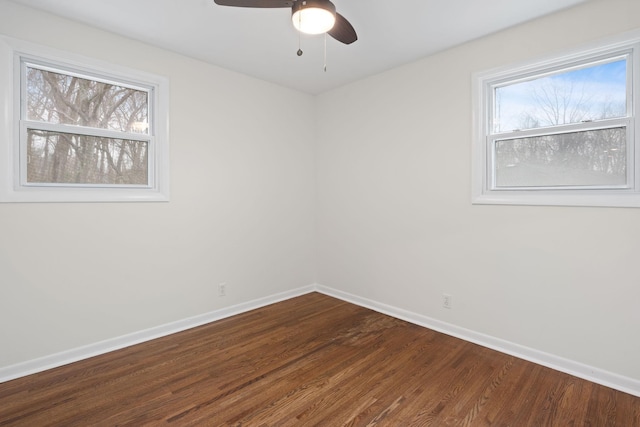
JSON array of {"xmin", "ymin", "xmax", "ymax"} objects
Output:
[{"xmin": 27, "ymin": 129, "xmax": 149, "ymax": 185}]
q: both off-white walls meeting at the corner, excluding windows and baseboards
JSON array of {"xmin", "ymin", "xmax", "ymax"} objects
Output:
[{"xmin": 0, "ymin": 0, "xmax": 640, "ymax": 392}]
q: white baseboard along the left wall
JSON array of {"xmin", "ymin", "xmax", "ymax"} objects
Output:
[{"xmin": 0, "ymin": 285, "xmax": 315, "ymax": 383}]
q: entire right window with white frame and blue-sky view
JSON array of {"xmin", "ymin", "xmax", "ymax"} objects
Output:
[{"xmin": 473, "ymin": 31, "xmax": 640, "ymax": 207}]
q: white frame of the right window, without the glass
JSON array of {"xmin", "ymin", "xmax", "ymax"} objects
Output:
[{"xmin": 471, "ymin": 32, "xmax": 640, "ymax": 207}]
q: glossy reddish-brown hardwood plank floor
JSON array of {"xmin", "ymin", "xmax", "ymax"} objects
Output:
[{"xmin": 0, "ymin": 293, "xmax": 640, "ymax": 427}]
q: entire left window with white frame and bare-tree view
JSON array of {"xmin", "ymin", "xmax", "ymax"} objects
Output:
[{"xmin": 0, "ymin": 38, "xmax": 168, "ymax": 202}]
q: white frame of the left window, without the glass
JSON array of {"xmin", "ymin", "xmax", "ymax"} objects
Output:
[{"xmin": 0, "ymin": 36, "xmax": 169, "ymax": 203}]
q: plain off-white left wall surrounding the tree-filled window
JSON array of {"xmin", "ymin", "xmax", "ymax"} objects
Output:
[{"xmin": 0, "ymin": 1, "xmax": 315, "ymax": 368}]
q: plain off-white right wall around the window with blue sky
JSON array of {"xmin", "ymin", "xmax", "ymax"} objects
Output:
[{"xmin": 317, "ymin": 0, "xmax": 640, "ymax": 380}]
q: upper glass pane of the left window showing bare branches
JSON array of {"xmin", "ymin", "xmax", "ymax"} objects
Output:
[{"xmin": 26, "ymin": 67, "xmax": 149, "ymax": 133}]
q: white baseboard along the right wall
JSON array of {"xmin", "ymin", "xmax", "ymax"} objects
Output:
[{"xmin": 315, "ymin": 285, "xmax": 640, "ymax": 397}]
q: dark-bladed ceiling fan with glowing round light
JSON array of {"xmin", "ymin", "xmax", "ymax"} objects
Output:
[{"xmin": 213, "ymin": 0, "xmax": 358, "ymax": 44}]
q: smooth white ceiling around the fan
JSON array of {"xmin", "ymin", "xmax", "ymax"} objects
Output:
[{"xmin": 12, "ymin": 0, "xmax": 589, "ymax": 94}]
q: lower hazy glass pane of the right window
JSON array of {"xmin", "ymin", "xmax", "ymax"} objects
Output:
[{"xmin": 495, "ymin": 127, "xmax": 627, "ymax": 187}]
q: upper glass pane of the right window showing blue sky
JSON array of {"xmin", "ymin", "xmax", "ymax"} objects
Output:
[{"xmin": 493, "ymin": 59, "xmax": 627, "ymax": 133}]
